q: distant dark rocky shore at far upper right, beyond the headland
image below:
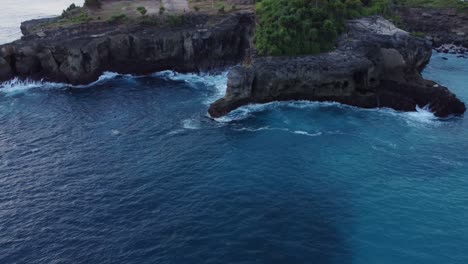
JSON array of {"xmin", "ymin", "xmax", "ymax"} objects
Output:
[{"xmin": 396, "ymin": 8, "xmax": 468, "ymax": 49}]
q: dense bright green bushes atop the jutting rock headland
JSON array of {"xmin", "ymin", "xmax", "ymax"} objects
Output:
[{"xmin": 255, "ymin": 0, "xmax": 391, "ymax": 55}]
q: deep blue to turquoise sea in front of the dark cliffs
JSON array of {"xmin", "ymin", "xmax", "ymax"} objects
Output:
[{"xmin": 0, "ymin": 0, "xmax": 468, "ymax": 264}]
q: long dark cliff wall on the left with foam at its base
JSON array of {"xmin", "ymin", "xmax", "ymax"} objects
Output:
[{"xmin": 0, "ymin": 12, "xmax": 255, "ymax": 84}]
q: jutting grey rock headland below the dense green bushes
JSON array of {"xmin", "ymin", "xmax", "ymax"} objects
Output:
[{"xmin": 209, "ymin": 17, "xmax": 465, "ymax": 117}]
